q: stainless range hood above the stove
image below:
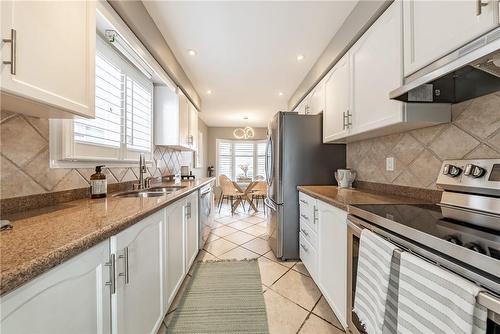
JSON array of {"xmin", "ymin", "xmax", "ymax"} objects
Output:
[{"xmin": 389, "ymin": 27, "xmax": 500, "ymax": 103}]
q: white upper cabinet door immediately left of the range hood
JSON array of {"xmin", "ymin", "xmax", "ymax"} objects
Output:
[{"xmin": 349, "ymin": 1, "xmax": 403, "ymax": 135}]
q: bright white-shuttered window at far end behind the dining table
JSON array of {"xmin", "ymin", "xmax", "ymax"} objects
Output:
[{"xmin": 217, "ymin": 139, "xmax": 266, "ymax": 180}]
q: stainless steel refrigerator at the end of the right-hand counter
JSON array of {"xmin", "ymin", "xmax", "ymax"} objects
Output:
[{"xmin": 265, "ymin": 111, "xmax": 346, "ymax": 260}]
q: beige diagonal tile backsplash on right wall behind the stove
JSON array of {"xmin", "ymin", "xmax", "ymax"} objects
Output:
[{"xmin": 347, "ymin": 93, "xmax": 500, "ymax": 189}]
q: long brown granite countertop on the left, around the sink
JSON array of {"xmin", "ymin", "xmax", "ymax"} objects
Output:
[{"xmin": 0, "ymin": 178, "xmax": 215, "ymax": 295}]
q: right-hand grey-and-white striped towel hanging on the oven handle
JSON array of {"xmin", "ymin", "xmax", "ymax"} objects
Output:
[{"xmin": 398, "ymin": 253, "xmax": 487, "ymax": 334}]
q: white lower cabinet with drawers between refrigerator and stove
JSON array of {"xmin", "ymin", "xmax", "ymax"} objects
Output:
[{"xmin": 299, "ymin": 193, "xmax": 347, "ymax": 328}]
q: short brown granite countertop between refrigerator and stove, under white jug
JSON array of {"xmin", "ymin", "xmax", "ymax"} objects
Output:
[{"xmin": 297, "ymin": 186, "xmax": 429, "ymax": 211}]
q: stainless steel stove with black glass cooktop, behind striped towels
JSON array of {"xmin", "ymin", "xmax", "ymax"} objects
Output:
[{"xmin": 347, "ymin": 159, "xmax": 500, "ymax": 334}]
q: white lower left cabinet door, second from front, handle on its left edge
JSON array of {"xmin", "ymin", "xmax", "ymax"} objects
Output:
[{"xmin": 111, "ymin": 210, "xmax": 165, "ymax": 334}]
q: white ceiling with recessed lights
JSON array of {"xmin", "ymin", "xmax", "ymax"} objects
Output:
[{"xmin": 144, "ymin": 0, "xmax": 356, "ymax": 126}]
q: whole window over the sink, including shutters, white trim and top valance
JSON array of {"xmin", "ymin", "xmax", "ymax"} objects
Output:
[{"xmin": 50, "ymin": 7, "xmax": 172, "ymax": 168}]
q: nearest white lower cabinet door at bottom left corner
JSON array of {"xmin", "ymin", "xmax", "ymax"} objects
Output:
[{"xmin": 0, "ymin": 240, "xmax": 111, "ymax": 334}]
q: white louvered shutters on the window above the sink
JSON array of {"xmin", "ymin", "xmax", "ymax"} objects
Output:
[{"xmin": 73, "ymin": 38, "xmax": 153, "ymax": 160}]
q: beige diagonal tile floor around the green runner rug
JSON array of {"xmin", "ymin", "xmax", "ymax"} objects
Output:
[{"xmin": 158, "ymin": 207, "xmax": 344, "ymax": 334}]
